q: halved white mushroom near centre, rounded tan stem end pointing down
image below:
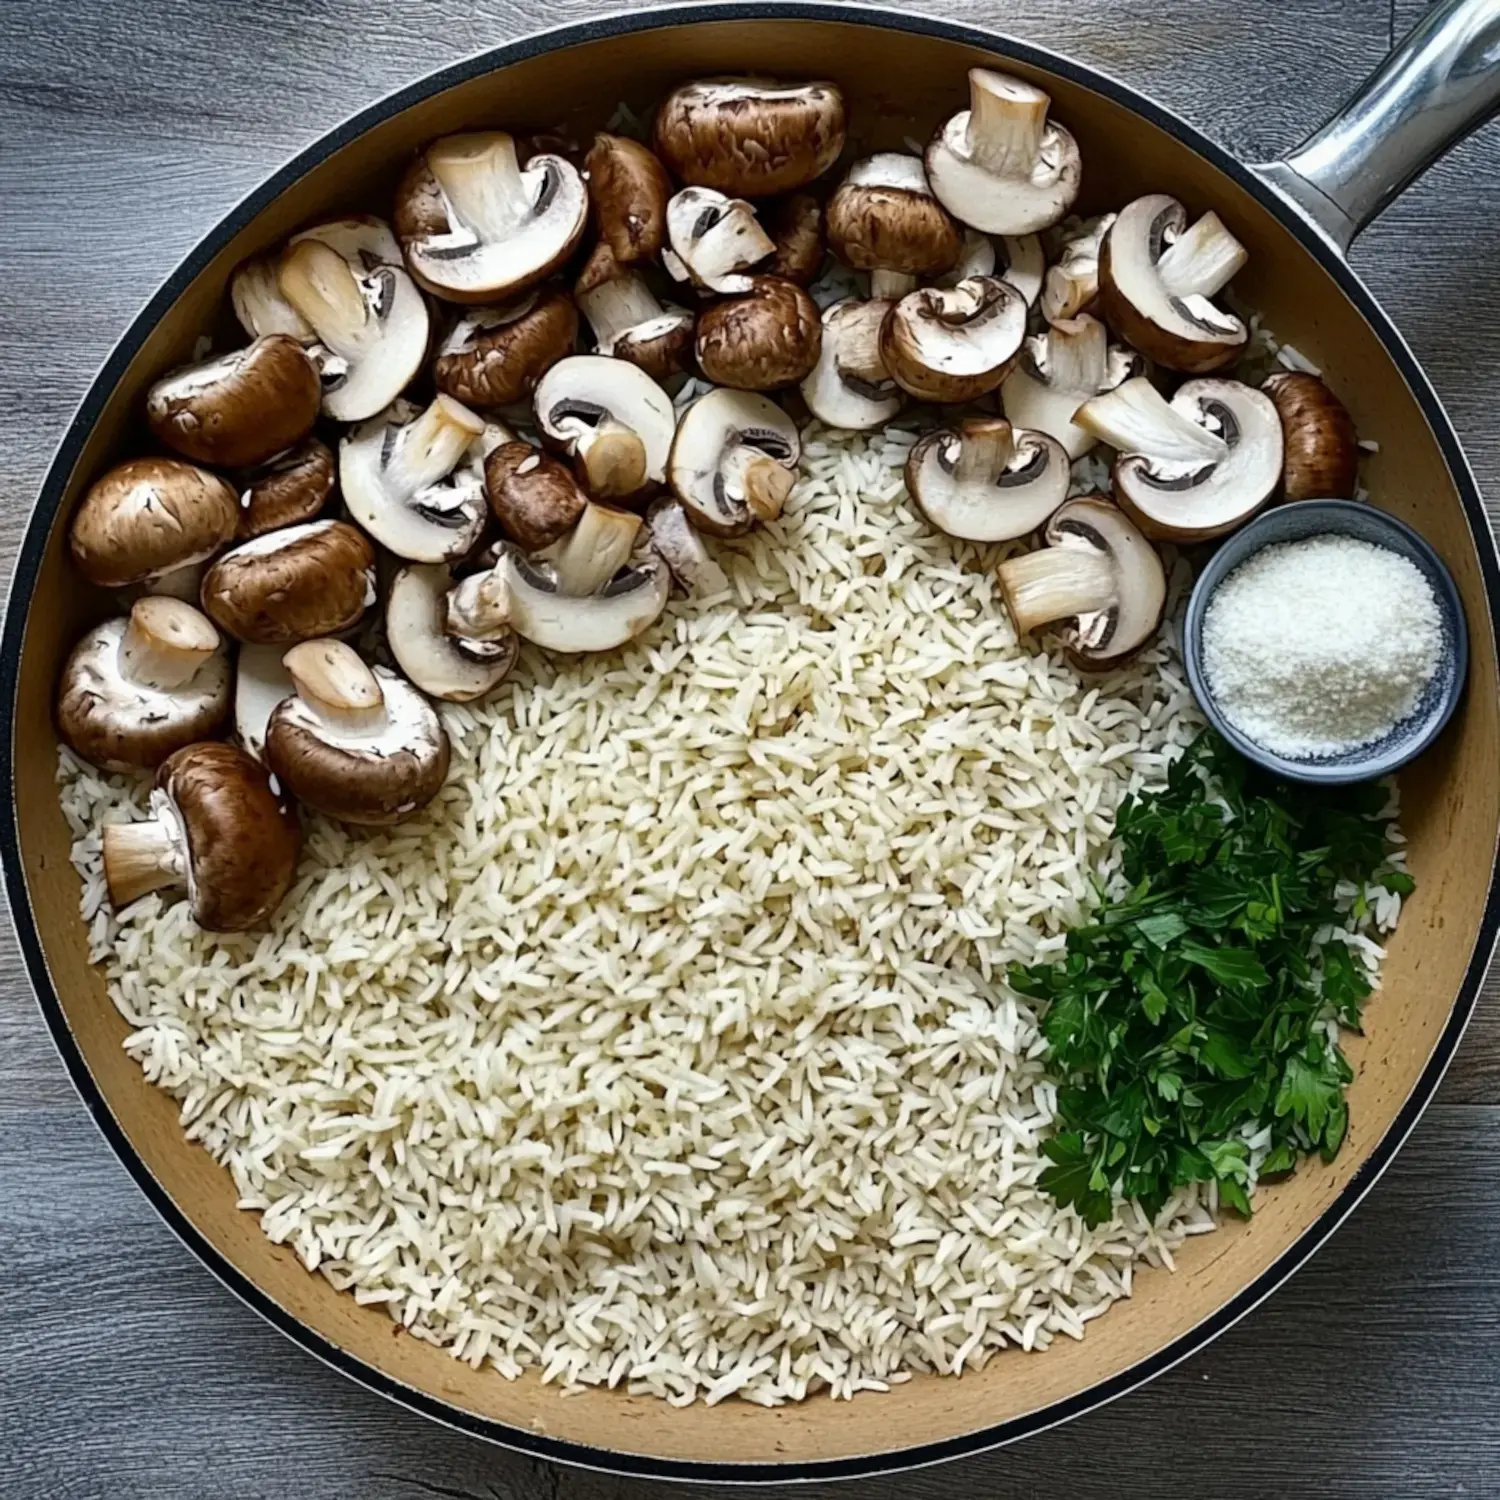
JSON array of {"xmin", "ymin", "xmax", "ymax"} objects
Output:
[{"xmin": 534, "ymin": 354, "xmax": 677, "ymax": 500}]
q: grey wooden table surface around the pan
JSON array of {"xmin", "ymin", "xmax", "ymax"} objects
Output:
[{"xmin": 0, "ymin": 0, "xmax": 1500, "ymax": 1500}]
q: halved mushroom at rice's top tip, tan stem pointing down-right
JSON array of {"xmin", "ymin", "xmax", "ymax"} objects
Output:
[{"xmin": 668, "ymin": 390, "xmax": 803, "ymax": 537}]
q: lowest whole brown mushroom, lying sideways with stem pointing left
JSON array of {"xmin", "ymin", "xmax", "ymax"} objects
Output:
[{"xmin": 104, "ymin": 744, "xmax": 302, "ymax": 933}]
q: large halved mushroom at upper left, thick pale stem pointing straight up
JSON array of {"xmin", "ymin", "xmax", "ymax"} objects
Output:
[{"xmin": 393, "ymin": 131, "xmax": 588, "ymax": 302}]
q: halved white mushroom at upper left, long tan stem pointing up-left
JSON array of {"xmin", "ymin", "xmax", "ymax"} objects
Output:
[{"xmin": 276, "ymin": 218, "xmax": 428, "ymax": 422}]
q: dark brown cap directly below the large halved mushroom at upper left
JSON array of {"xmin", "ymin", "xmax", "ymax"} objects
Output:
[{"xmin": 432, "ymin": 287, "xmax": 578, "ymax": 411}]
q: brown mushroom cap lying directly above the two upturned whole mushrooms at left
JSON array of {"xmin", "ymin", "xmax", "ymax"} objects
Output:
[{"xmin": 203, "ymin": 521, "xmax": 375, "ymax": 645}]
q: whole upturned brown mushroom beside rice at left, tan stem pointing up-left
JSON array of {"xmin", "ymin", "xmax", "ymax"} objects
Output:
[{"xmin": 266, "ymin": 641, "xmax": 449, "ymax": 825}]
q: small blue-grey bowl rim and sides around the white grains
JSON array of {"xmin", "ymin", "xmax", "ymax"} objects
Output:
[{"xmin": 1182, "ymin": 500, "xmax": 1469, "ymax": 786}]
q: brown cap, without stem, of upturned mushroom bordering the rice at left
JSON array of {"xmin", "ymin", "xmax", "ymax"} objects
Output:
[{"xmin": 266, "ymin": 654, "xmax": 450, "ymax": 827}]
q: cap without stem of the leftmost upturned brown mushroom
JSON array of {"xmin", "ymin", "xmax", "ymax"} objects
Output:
[{"xmin": 57, "ymin": 606, "xmax": 230, "ymax": 771}]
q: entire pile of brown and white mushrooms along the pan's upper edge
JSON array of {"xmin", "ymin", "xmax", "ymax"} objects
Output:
[{"xmin": 57, "ymin": 68, "xmax": 1356, "ymax": 932}]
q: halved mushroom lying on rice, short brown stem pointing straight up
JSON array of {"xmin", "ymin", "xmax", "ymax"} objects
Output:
[{"xmin": 906, "ymin": 417, "xmax": 1070, "ymax": 542}]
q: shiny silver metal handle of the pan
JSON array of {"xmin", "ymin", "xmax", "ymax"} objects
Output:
[{"xmin": 1256, "ymin": 0, "xmax": 1500, "ymax": 251}]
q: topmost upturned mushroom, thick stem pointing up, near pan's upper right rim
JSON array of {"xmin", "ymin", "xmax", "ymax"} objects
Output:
[{"xmin": 927, "ymin": 68, "xmax": 1083, "ymax": 234}]
